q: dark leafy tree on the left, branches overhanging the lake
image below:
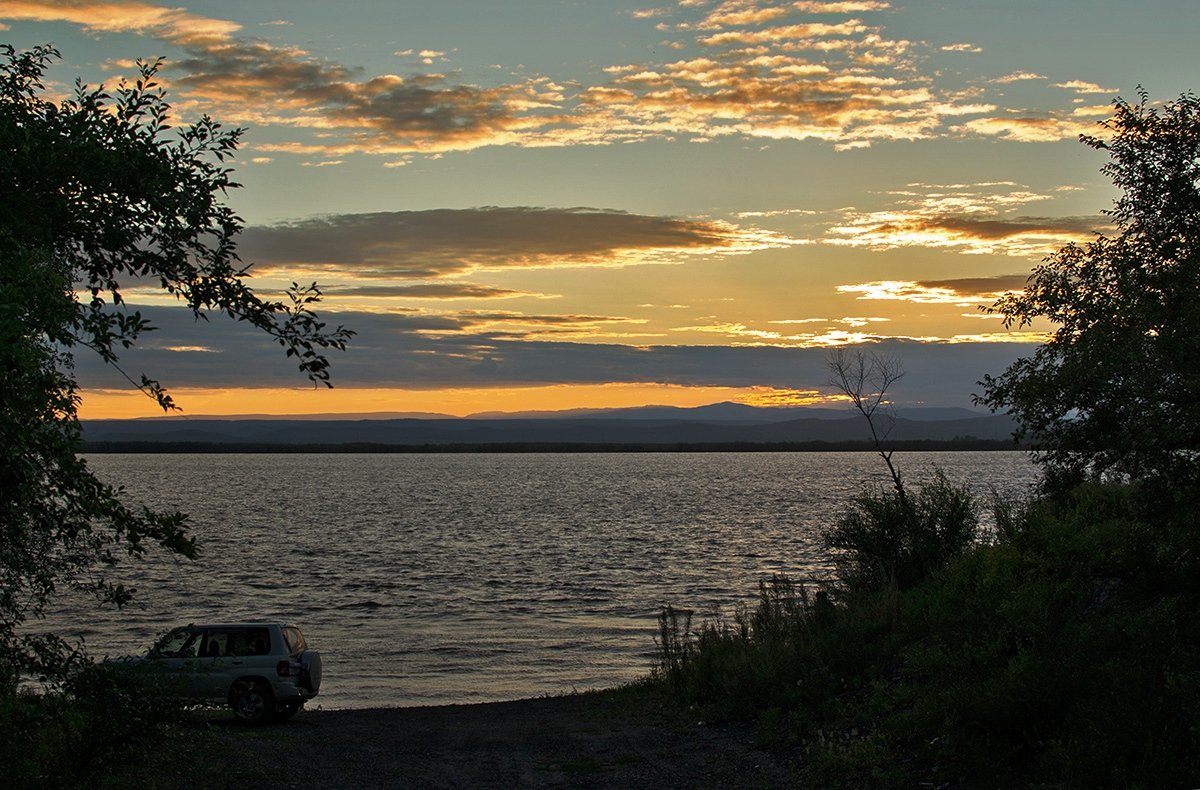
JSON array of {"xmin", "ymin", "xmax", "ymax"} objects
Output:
[{"xmin": 0, "ymin": 46, "xmax": 353, "ymax": 689}]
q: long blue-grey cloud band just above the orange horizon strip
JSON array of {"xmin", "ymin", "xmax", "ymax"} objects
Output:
[{"xmin": 70, "ymin": 307, "xmax": 1032, "ymax": 406}]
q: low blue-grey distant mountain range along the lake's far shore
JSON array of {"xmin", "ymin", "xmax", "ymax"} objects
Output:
[{"xmin": 83, "ymin": 403, "xmax": 1016, "ymax": 450}]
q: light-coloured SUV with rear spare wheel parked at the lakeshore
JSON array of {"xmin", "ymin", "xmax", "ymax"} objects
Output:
[{"xmin": 136, "ymin": 623, "xmax": 320, "ymax": 724}]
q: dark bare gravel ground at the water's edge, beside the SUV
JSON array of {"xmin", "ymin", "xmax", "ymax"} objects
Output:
[{"xmin": 211, "ymin": 694, "xmax": 799, "ymax": 789}]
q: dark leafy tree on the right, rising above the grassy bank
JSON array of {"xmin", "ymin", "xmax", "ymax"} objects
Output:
[{"xmin": 979, "ymin": 92, "xmax": 1200, "ymax": 487}]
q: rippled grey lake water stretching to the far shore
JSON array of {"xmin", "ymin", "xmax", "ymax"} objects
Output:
[{"xmin": 49, "ymin": 453, "xmax": 1036, "ymax": 708}]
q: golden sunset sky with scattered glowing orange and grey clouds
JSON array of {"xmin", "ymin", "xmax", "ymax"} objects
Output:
[{"xmin": 0, "ymin": 0, "xmax": 1200, "ymax": 418}]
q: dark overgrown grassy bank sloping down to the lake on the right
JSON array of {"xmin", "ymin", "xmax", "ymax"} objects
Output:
[{"xmin": 658, "ymin": 477, "xmax": 1200, "ymax": 788}]
